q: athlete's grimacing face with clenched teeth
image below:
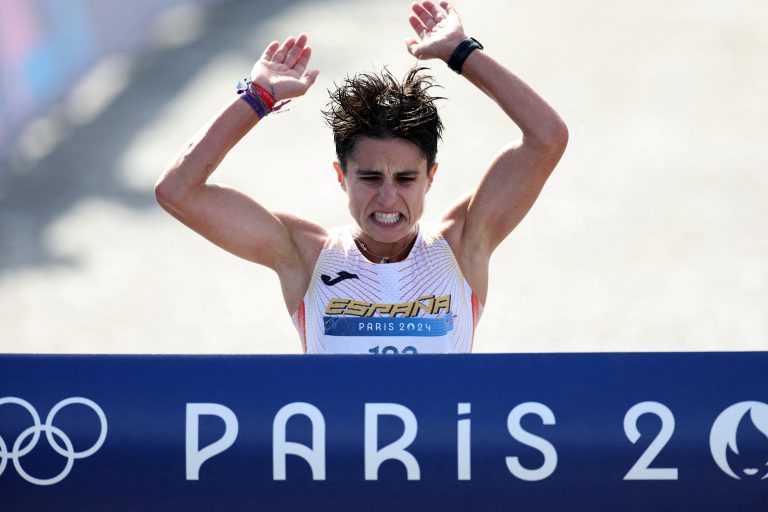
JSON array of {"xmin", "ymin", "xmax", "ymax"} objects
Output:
[{"xmin": 334, "ymin": 137, "xmax": 437, "ymax": 248}]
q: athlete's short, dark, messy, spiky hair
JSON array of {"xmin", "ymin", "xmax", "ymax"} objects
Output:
[{"xmin": 323, "ymin": 67, "xmax": 443, "ymax": 173}]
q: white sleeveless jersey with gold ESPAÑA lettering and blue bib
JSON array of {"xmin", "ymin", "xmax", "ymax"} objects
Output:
[{"xmin": 291, "ymin": 226, "xmax": 482, "ymax": 354}]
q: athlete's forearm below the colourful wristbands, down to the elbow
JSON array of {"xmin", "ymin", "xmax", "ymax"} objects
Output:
[{"xmin": 155, "ymin": 98, "xmax": 259, "ymax": 203}]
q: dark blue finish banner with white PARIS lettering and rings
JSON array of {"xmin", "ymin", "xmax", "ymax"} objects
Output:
[{"xmin": 0, "ymin": 352, "xmax": 768, "ymax": 512}]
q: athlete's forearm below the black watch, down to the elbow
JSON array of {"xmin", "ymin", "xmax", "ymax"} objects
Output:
[{"xmin": 461, "ymin": 50, "xmax": 568, "ymax": 145}]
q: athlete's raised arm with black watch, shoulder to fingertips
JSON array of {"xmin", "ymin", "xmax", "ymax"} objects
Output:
[{"xmin": 406, "ymin": 1, "xmax": 568, "ymax": 296}]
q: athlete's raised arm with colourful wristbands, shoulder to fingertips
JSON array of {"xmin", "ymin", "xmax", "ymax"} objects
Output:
[{"xmin": 155, "ymin": 34, "xmax": 324, "ymax": 308}]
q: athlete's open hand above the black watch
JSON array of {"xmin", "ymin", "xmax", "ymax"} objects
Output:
[{"xmin": 405, "ymin": 0, "xmax": 467, "ymax": 62}]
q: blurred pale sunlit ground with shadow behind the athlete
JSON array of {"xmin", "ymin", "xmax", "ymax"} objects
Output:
[{"xmin": 0, "ymin": 0, "xmax": 768, "ymax": 353}]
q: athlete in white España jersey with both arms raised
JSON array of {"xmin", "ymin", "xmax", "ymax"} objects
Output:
[{"xmin": 155, "ymin": 1, "xmax": 568, "ymax": 354}]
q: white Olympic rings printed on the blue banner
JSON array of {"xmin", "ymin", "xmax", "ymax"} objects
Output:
[{"xmin": 0, "ymin": 396, "xmax": 107, "ymax": 485}]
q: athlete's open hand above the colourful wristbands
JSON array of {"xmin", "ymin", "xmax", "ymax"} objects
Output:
[{"xmin": 251, "ymin": 34, "xmax": 320, "ymax": 101}]
